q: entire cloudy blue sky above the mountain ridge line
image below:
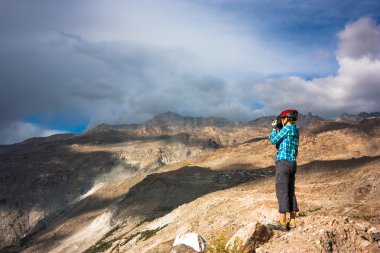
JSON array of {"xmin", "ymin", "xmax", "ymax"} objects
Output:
[{"xmin": 0, "ymin": 0, "xmax": 380, "ymax": 144}]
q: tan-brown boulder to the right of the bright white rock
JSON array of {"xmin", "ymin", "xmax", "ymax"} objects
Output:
[{"xmin": 226, "ymin": 222, "xmax": 273, "ymax": 252}]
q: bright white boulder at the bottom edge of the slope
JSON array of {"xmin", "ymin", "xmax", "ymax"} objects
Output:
[{"xmin": 172, "ymin": 232, "xmax": 207, "ymax": 253}]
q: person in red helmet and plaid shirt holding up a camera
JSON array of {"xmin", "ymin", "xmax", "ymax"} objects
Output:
[{"xmin": 269, "ymin": 110, "xmax": 299, "ymax": 231}]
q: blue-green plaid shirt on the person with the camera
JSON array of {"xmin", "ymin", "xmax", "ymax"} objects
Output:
[{"xmin": 269, "ymin": 124, "xmax": 299, "ymax": 162}]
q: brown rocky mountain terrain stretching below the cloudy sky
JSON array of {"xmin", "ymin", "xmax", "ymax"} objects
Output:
[{"xmin": 0, "ymin": 113, "xmax": 380, "ymax": 252}]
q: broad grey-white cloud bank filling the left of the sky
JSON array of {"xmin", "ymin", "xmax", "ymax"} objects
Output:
[{"xmin": 0, "ymin": 0, "xmax": 314, "ymax": 131}]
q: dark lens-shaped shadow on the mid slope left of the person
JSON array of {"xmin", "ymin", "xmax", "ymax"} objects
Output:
[{"xmin": 117, "ymin": 166, "xmax": 252, "ymax": 220}]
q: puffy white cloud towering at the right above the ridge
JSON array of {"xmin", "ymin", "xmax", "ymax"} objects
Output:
[{"xmin": 256, "ymin": 17, "xmax": 380, "ymax": 117}]
